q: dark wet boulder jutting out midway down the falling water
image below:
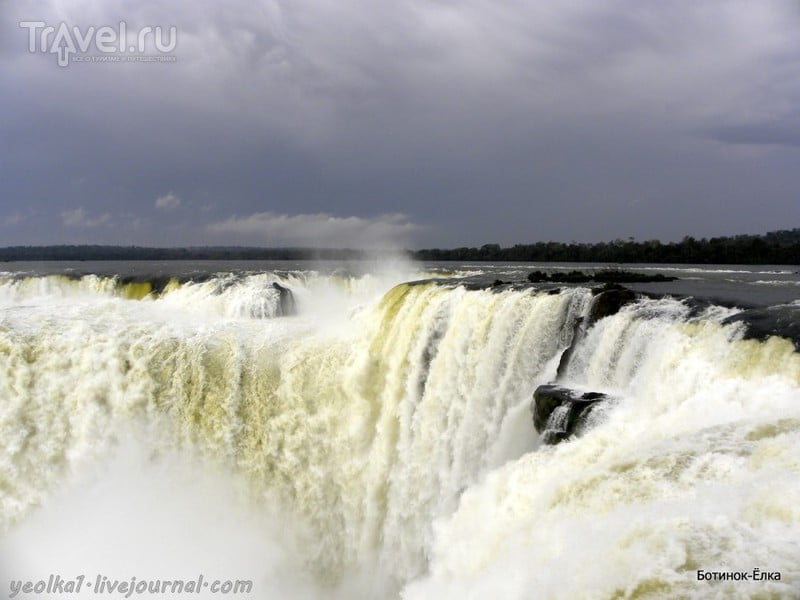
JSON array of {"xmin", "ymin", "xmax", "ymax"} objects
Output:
[{"xmin": 531, "ymin": 385, "xmax": 608, "ymax": 445}]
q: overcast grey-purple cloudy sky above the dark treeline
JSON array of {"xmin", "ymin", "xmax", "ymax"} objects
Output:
[{"xmin": 0, "ymin": 0, "xmax": 800, "ymax": 248}]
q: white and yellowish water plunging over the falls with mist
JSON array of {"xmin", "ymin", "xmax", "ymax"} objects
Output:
[{"xmin": 0, "ymin": 267, "xmax": 800, "ymax": 599}]
